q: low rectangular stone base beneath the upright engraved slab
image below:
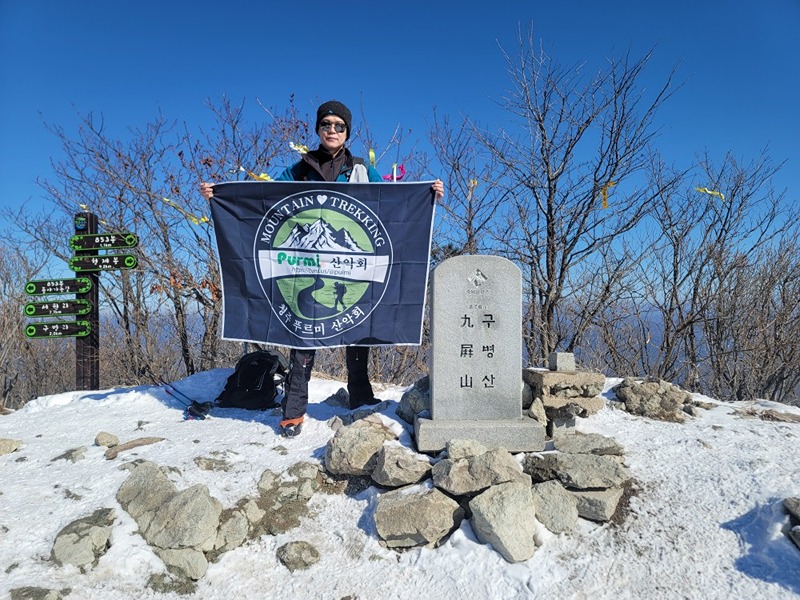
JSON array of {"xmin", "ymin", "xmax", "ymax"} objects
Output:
[{"xmin": 414, "ymin": 417, "xmax": 545, "ymax": 453}]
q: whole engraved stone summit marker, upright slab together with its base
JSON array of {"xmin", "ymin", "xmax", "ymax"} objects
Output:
[{"xmin": 414, "ymin": 256, "xmax": 545, "ymax": 452}]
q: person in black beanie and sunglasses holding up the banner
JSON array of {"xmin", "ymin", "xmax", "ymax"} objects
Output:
[{"xmin": 200, "ymin": 100, "xmax": 444, "ymax": 437}]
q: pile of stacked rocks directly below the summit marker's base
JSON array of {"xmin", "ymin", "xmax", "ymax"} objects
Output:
[{"xmin": 325, "ymin": 415, "xmax": 631, "ymax": 562}]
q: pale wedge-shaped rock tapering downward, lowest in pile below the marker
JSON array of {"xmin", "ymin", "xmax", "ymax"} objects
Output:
[{"xmin": 469, "ymin": 481, "xmax": 536, "ymax": 563}]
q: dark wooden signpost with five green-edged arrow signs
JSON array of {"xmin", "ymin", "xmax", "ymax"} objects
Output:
[{"xmin": 24, "ymin": 212, "xmax": 139, "ymax": 390}]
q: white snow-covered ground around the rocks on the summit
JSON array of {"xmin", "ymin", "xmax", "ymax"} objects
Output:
[{"xmin": 0, "ymin": 369, "xmax": 800, "ymax": 600}]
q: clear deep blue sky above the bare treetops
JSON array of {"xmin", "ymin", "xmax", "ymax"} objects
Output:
[{"xmin": 0, "ymin": 0, "xmax": 800, "ymax": 213}]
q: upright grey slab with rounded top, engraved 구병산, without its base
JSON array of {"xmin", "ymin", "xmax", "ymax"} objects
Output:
[{"xmin": 429, "ymin": 256, "xmax": 522, "ymax": 421}]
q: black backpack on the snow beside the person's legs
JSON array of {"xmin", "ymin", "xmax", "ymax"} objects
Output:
[{"xmin": 214, "ymin": 350, "xmax": 289, "ymax": 410}]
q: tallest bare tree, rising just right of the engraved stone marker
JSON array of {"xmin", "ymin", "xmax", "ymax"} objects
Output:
[{"xmin": 460, "ymin": 31, "xmax": 673, "ymax": 362}]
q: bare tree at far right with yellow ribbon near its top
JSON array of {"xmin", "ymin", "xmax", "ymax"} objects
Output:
[{"xmin": 640, "ymin": 150, "xmax": 786, "ymax": 390}]
